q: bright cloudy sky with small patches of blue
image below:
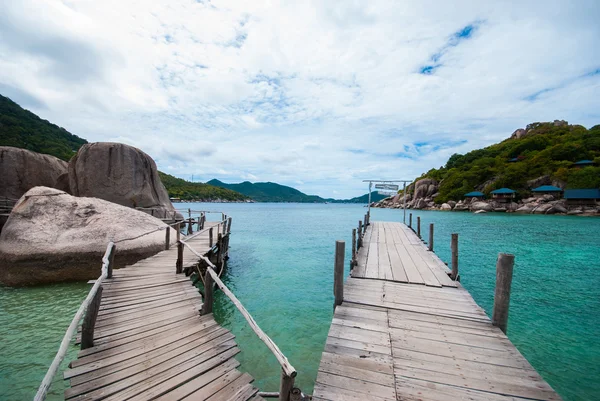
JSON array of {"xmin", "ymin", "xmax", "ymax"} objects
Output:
[{"xmin": 0, "ymin": 0, "xmax": 600, "ymax": 198}]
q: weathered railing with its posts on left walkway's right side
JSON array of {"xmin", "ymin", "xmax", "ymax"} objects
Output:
[{"xmin": 178, "ymin": 231, "xmax": 302, "ymax": 401}]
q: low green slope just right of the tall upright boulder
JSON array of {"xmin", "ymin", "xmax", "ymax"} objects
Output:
[{"xmin": 158, "ymin": 171, "xmax": 249, "ymax": 201}]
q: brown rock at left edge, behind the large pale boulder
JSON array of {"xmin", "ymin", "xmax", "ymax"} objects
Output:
[{"xmin": 0, "ymin": 146, "xmax": 67, "ymax": 199}]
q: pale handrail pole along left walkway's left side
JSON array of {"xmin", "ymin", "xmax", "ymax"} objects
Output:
[{"xmin": 34, "ymin": 242, "xmax": 115, "ymax": 401}]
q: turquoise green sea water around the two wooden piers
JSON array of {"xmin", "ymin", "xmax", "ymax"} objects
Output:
[{"xmin": 0, "ymin": 203, "xmax": 600, "ymax": 400}]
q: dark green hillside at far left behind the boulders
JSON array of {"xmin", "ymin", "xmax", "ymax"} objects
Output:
[{"xmin": 0, "ymin": 95, "xmax": 87, "ymax": 161}]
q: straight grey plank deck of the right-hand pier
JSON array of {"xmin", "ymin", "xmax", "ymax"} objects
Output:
[{"xmin": 313, "ymin": 222, "xmax": 560, "ymax": 401}]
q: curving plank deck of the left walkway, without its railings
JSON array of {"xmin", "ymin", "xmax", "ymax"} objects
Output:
[{"xmin": 64, "ymin": 222, "xmax": 262, "ymax": 400}]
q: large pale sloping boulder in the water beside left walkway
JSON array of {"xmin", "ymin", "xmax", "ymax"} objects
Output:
[{"xmin": 0, "ymin": 187, "xmax": 176, "ymax": 286}]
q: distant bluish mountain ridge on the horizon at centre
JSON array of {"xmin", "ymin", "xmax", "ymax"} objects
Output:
[{"xmin": 207, "ymin": 179, "xmax": 385, "ymax": 203}]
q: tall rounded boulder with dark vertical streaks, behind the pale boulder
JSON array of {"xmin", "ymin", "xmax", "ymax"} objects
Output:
[{"xmin": 69, "ymin": 142, "xmax": 175, "ymax": 217}]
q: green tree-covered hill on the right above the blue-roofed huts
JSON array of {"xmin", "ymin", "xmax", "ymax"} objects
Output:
[{"xmin": 420, "ymin": 121, "xmax": 600, "ymax": 203}]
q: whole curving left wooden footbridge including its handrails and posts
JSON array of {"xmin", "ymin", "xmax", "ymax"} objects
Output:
[{"xmin": 36, "ymin": 211, "xmax": 300, "ymax": 401}]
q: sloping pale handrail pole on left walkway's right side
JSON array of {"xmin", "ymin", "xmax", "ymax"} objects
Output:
[{"xmin": 180, "ymin": 240, "xmax": 297, "ymax": 378}]
